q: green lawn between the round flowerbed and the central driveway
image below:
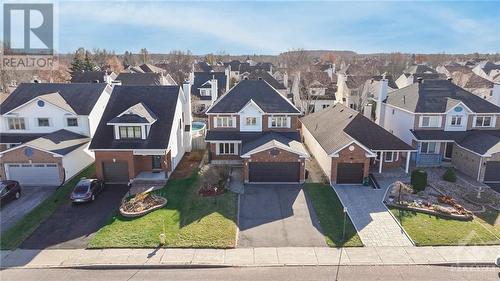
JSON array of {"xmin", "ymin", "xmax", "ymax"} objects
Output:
[{"xmin": 89, "ymin": 168, "xmax": 237, "ymax": 248}]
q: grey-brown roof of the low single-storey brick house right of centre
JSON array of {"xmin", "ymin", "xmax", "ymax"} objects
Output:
[{"xmin": 300, "ymin": 103, "xmax": 414, "ymax": 154}]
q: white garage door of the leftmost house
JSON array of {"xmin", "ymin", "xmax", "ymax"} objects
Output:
[{"xmin": 6, "ymin": 164, "xmax": 61, "ymax": 186}]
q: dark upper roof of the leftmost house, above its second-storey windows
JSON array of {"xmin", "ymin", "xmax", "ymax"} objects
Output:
[{"xmin": 0, "ymin": 83, "xmax": 107, "ymax": 115}]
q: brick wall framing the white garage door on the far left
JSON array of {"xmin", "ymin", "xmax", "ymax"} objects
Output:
[{"xmin": 0, "ymin": 147, "xmax": 64, "ymax": 182}]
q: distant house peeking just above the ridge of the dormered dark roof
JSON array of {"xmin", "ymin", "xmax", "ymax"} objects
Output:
[{"xmin": 114, "ymin": 72, "xmax": 177, "ymax": 86}]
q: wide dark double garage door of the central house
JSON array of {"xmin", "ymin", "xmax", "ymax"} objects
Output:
[{"xmin": 248, "ymin": 162, "xmax": 300, "ymax": 182}]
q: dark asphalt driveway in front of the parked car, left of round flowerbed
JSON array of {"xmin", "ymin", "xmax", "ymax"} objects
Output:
[{"xmin": 21, "ymin": 185, "xmax": 128, "ymax": 249}]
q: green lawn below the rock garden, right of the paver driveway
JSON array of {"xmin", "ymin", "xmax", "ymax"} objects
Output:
[{"xmin": 391, "ymin": 208, "xmax": 500, "ymax": 246}]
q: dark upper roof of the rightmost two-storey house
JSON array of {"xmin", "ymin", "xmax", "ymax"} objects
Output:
[{"xmin": 386, "ymin": 77, "xmax": 500, "ymax": 113}]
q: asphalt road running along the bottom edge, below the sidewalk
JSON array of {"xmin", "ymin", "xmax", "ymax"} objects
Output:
[{"xmin": 0, "ymin": 266, "xmax": 500, "ymax": 281}]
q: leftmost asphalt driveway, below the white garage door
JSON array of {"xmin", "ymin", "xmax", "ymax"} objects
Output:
[{"xmin": 0, "ymin": 186, "xmax": 57, "ymax": 232}]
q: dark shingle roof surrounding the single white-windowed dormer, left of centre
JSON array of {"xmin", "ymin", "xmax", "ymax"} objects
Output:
[{"xmin": 90, "ymin": 86, "xmax": 180, "ymax": 149}]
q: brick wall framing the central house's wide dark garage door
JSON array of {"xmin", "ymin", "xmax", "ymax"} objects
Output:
[{"xmin": 243, "ymin": 145, "xmax": 305, "ymax": 182}]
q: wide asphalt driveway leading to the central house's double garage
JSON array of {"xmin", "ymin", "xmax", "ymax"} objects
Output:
[{"xmin": 238, "ymin": 184, "xmax": 326, "ymax": 247}]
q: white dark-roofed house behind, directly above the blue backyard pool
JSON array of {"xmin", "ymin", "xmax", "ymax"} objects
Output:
[{"xmin": 191, "ymin": 72, "xmax": 229, "ymax": 114}]
